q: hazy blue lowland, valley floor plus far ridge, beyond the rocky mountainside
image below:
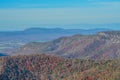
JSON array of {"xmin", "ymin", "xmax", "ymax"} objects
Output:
[{"xmin": 0, "ymin": 28, "xmax": 110, "ymax": 54}]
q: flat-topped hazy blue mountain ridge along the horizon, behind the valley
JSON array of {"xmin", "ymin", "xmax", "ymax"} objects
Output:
[{"xmin": 0, "ymin": 28, "xmax": 109, "ymax": 43}]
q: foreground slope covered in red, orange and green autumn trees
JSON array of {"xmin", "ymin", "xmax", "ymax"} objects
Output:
[{"xmin": 0, "ymin": 54, "xmax": 120, "ymax": 80}]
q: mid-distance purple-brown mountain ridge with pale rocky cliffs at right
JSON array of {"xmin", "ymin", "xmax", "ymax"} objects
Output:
[{"xmin": 16, "ymin": 31, "xmax": 120, "ymax": 59}]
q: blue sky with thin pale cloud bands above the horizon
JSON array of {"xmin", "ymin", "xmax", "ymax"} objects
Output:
[{"xmin": 0, "ymin": 0, "xmax": 120, "ymax": 31}]
